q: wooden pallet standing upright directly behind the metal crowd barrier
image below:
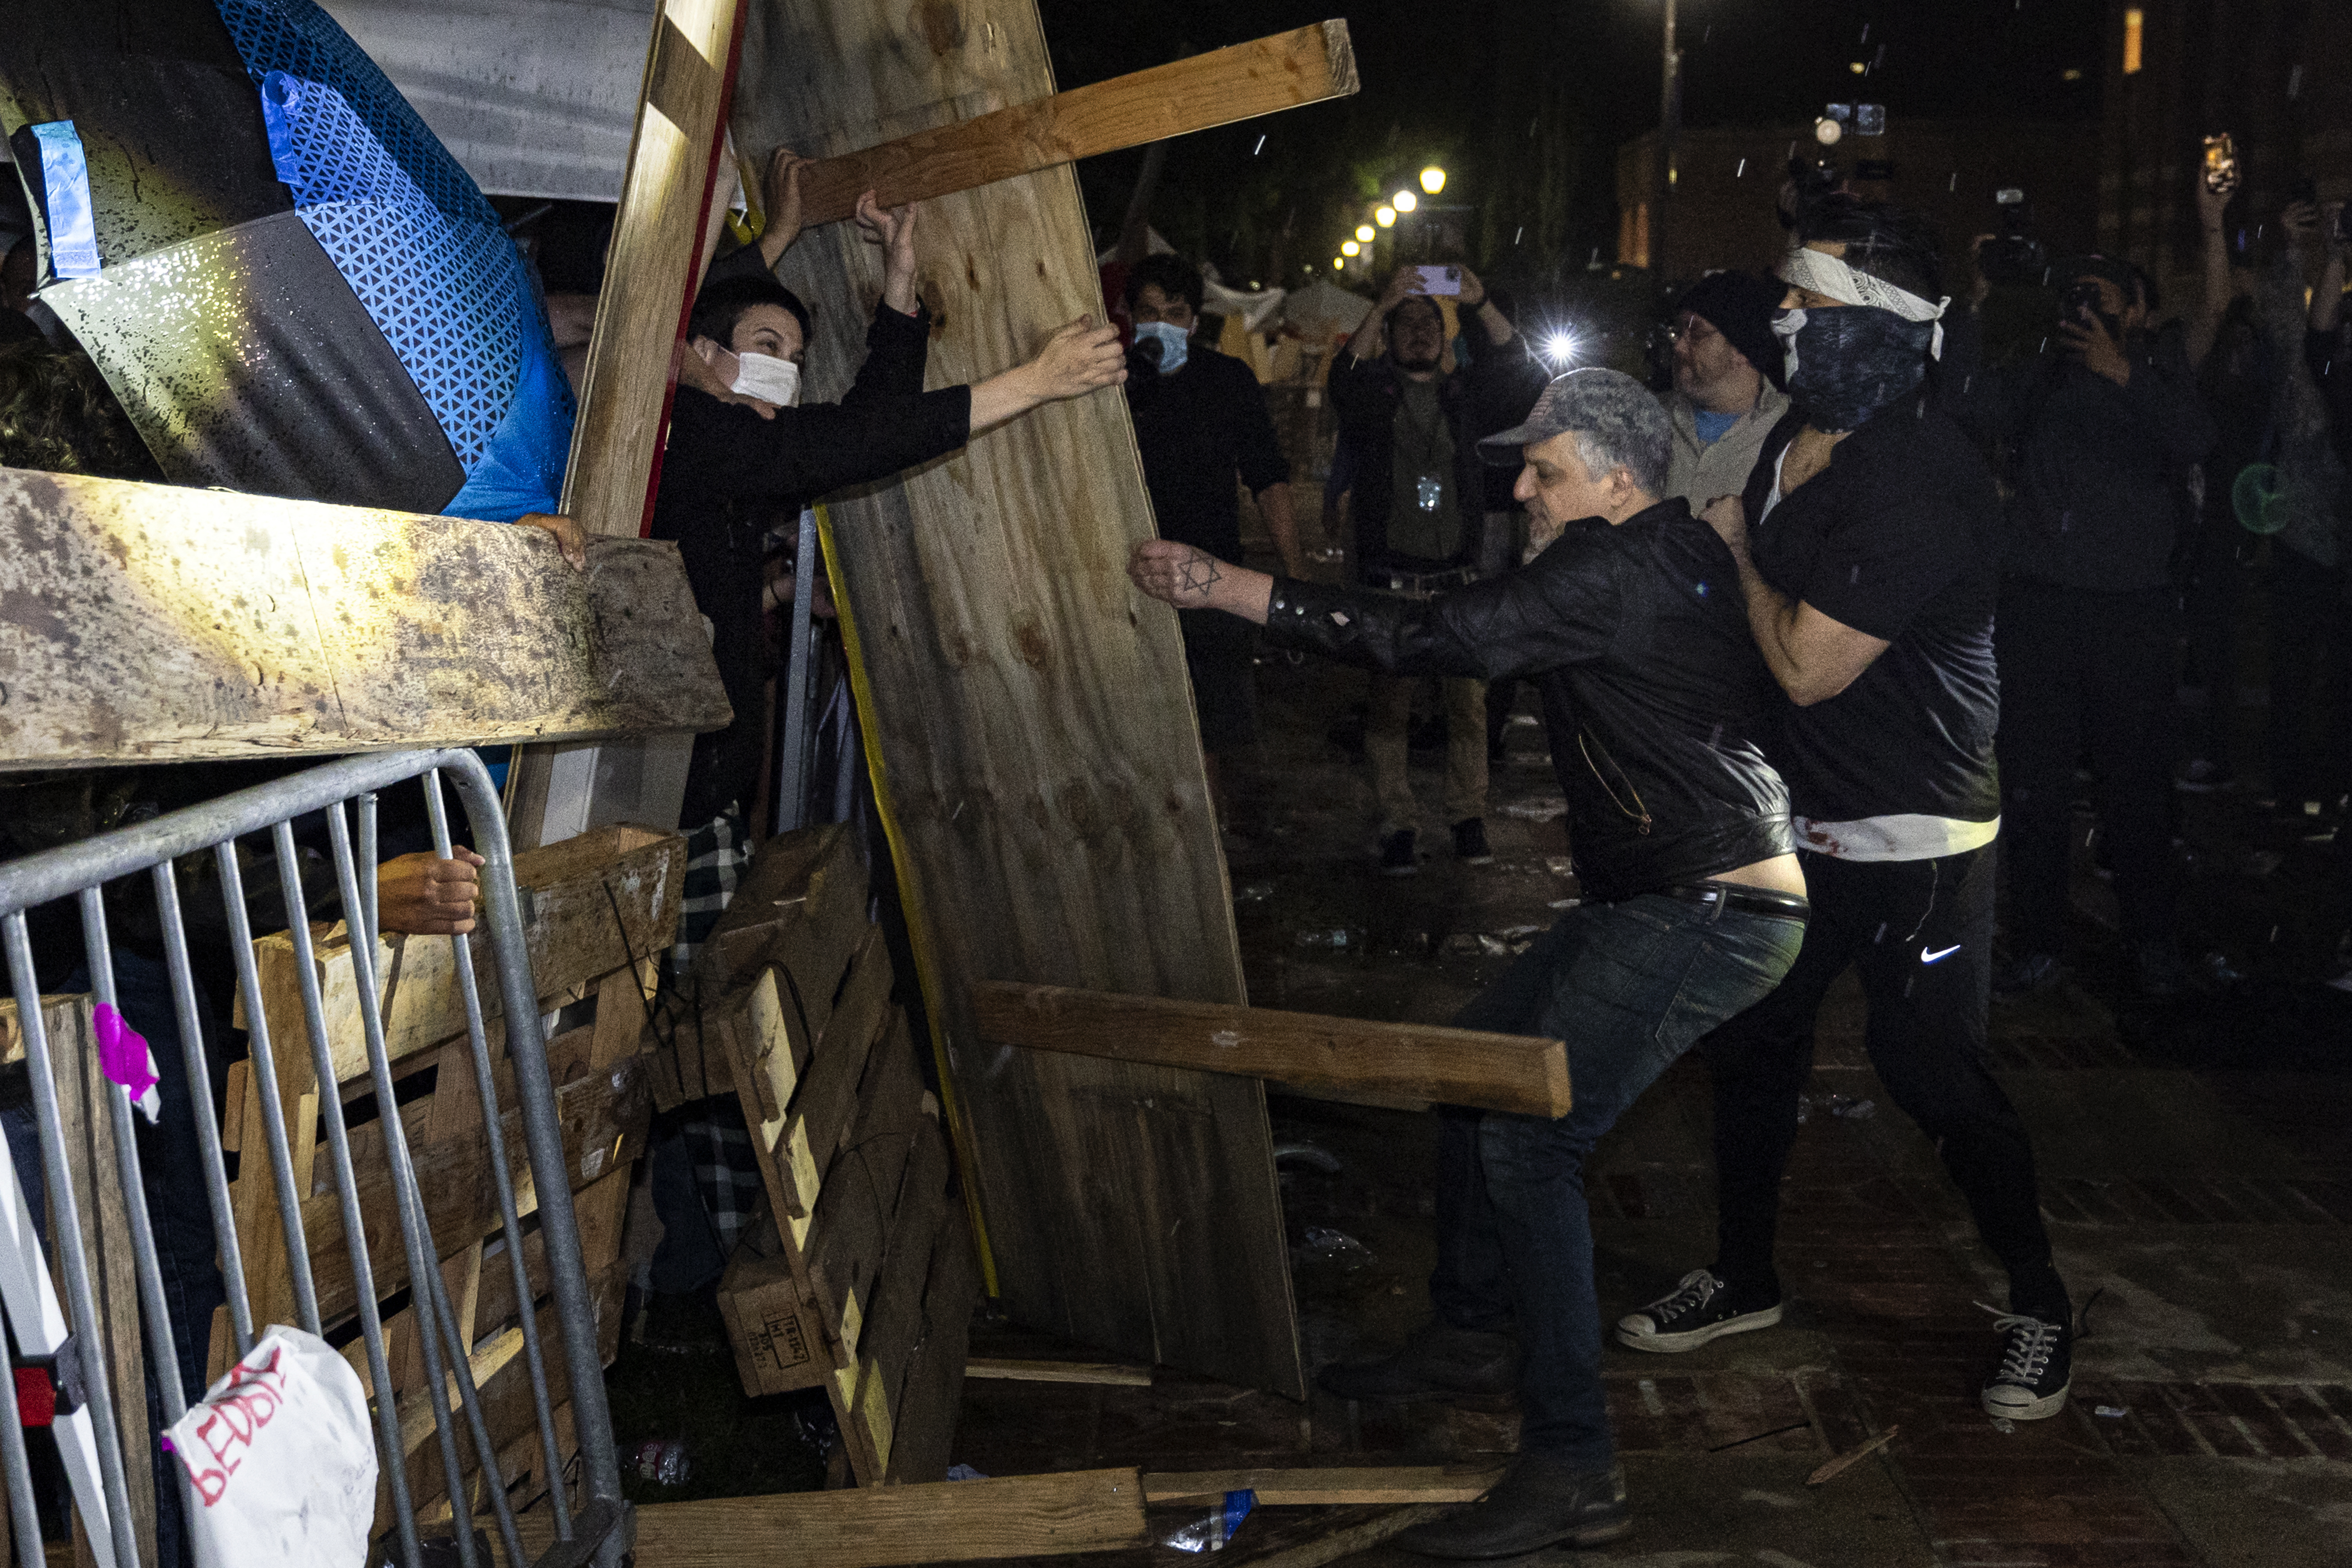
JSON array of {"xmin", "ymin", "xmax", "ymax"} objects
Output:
[{"xmin": 212, "ymin": 825, "xmax": 687, "ymax": 1528}]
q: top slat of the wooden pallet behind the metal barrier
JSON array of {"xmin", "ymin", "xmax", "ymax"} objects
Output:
[{"xmin": 238, "ymin": 825, "xmax": 687, "ymax": 1086}]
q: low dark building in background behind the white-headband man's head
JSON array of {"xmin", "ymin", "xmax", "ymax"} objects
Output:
[{"xmin": 1616, "ymin": 119, "xmax": 2100, "ymax": 294}]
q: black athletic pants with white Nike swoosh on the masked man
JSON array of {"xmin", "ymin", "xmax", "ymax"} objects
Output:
[{"xmin": 1698, "ymin": 844, "xmax": 2070, "ymax": 1323}]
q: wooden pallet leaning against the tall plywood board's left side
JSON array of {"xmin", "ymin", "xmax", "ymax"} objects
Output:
[{"xmin": 694, "ymin": 825, "xmax": 978, "ymax": 1486}]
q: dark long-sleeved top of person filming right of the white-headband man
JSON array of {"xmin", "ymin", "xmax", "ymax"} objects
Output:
[{"xmin": 1943, "ymin": 310, "xmax": 2220, "ymax": 592}]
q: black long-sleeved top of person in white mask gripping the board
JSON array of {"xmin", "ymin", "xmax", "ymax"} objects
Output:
[{"xmin": 654, "ymin": 290, "xmax": 971, "ymax": 828}]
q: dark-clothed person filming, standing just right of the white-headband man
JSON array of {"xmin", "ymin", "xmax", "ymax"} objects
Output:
[{"xmin": 1943, "ymin": 256, "xmax": 2216, "ymax": 997}]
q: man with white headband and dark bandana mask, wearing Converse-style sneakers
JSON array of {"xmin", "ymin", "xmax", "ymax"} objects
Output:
[{"xmin": 1618, "ymin": 195, "xmax": 2072, "ymax": 1420}]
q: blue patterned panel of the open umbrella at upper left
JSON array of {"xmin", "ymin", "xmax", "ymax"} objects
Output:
[{"xmin": 219, "ymin": 0, "xmax": 569, "ymax": 475}]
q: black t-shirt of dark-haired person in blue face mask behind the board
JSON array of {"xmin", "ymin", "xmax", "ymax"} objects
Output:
[{"xmin": 1127, "ymin": 343, "xmax": 1291, "ymax": 562}]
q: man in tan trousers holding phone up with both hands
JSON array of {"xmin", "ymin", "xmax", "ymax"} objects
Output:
[{"xmin": 1331, "ymin": 263, "xmax": 1543, "ymax": 877}]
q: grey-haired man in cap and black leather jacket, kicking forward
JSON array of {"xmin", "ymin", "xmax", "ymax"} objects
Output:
[{"xmin": 1129, "ymin": 369, "xmax": 1809, "ymax": 1556}]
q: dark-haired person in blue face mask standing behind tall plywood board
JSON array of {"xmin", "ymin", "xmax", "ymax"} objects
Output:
[{"xmin": 1124, "ymin": 254, "xmax": 1305, "ymax": 823}]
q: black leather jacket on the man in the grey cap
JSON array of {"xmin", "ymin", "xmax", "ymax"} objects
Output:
[{"xmin": 1265, "ymin": 501, "xmax": 1795, "ymax": 903}]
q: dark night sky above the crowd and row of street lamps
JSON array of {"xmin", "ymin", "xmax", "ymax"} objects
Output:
[{"xmin": 1040, "ymin": 0, "xmax": 2103, "ymax": 282}]
